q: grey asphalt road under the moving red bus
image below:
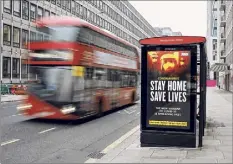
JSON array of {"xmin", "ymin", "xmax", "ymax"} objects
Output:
[{"xmin": 0, "ymin": 100, "xmax": 140, "ymax": 164}]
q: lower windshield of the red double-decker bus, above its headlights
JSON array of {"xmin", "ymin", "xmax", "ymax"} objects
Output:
[{"xmin": 29, "ymin": 66, "xmax": 72, "ymax": 101}]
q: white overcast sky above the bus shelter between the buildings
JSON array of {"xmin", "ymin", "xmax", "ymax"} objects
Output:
[{"xmin": 130, "ymin": 0, "xmax": 207, "ymax": 36}]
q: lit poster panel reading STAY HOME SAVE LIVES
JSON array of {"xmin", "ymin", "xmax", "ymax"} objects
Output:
[{"xmin": 146, "ymin": 51, "xmax": 191, "ymax": 129}]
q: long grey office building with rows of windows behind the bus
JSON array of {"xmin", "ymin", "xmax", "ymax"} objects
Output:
[{"xmin": 0, "ymin": 0, "xmax": 158, "ymax": 83}]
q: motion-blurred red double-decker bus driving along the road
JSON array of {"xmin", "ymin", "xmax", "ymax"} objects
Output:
[{"xmin": 18, "ymin": 17, "xmax": 140, "ymax": 120}]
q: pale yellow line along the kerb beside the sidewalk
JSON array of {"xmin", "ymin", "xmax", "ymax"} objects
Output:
[{"xmin": 85, "ymin": 125, "xmax": 140, "ymax": 163}]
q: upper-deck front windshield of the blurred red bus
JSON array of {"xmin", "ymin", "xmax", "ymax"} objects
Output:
[{"xmin": 37, "ymin": 26, "xmax": 80, "ymax": 42}]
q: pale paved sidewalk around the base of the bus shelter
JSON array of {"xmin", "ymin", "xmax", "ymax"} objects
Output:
[{"xmin": 86, "ymin": 88, "xmax": 232, "ymax": 163}]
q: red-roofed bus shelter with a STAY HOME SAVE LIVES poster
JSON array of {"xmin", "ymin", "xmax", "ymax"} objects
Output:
[{"xmin": 140, "ymin": 36, "xmax": 207, "ymax": 148}]
